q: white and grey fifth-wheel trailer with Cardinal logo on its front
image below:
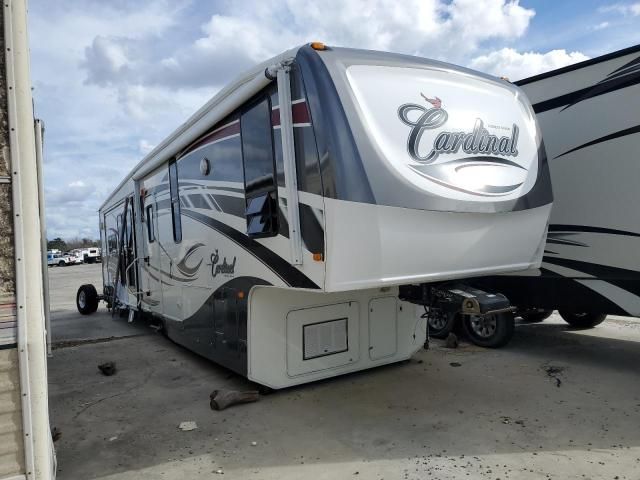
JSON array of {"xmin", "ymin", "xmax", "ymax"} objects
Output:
[{"xmin": 77, "ymin": 44, "xmax": 552, "ymax": 388}]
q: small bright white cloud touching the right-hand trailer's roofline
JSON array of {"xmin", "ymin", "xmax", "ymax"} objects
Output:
[{"xmin": 469, "ymin": 48, "xmax": 589, "ymax": 81}]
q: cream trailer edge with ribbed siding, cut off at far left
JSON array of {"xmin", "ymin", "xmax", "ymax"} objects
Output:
[{"xmin": 0, "ymin": 0, "xmax": 55, "ymax": 480}]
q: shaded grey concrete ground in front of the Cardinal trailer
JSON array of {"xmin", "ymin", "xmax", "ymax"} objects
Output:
[{"xmin": 49, "ymin": 316, "xmax": 640, "ymax": 480}]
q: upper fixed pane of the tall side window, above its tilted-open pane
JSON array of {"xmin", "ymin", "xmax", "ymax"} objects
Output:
[{"xmin": 240, "ymin": 98, "xmax": 276, "ymax": 197}]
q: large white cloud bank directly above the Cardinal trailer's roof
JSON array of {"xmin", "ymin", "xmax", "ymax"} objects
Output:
[{"xmin": 83, "ymin": 0, "xmax": 535, "ymax": 89}]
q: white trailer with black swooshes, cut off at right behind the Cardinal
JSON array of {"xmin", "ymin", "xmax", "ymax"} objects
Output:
[{"xmin": 470, "ymin": 45, "xmax": 640, "ymax": 328}]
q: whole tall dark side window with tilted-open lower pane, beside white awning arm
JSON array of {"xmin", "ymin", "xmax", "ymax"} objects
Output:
[{"xmin": 240, "ymin": 97, "xmax": 278, "ymax": 237}]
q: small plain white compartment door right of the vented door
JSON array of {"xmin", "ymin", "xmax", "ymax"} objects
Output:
[{"xmin": 369, "ymin": 297, "xmax": 398, "ymax": 360}]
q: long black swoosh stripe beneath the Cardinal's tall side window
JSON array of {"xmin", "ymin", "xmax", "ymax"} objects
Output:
[{"xmin": 182, "ymin": 209, "xmax": 320, "ymax": 289}]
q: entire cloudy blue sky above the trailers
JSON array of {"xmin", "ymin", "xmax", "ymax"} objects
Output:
[{"xmin": 29, "ymin": 0, "xmax": 640, "ymax": 238}]
